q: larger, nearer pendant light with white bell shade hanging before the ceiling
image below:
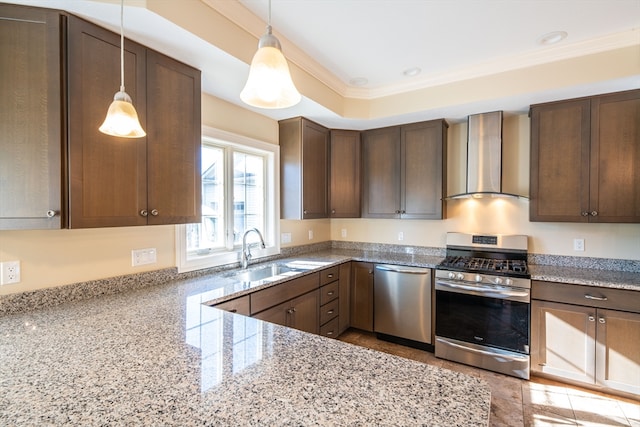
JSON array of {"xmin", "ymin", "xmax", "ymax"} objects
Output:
[{"xmin": 240, "ymin": 0, "xmax": 302, "ymax": 108}]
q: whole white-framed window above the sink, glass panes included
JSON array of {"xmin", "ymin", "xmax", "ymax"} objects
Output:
[{"xmin": 176, "ymin": 128, "xmax": 280, "ymax": 272}]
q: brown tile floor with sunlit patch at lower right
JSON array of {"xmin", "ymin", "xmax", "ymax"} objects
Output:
[{"xmin": 338, "ymin": 329, "xmax": 640, "ymax": 427}]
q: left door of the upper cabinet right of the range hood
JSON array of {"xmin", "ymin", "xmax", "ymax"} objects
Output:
[{"xmin": 529, "ymin": 99, "xmax": 591, "ymax": 222}]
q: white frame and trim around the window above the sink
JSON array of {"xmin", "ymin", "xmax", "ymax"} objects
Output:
[{"xmin": 175, "ymin": 126, "xmax": 280, "ymax": 273}]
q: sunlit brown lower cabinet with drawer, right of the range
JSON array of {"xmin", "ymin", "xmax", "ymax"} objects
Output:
[{"xmin": 531, "ymin": 281, "xmax": 640, "ymax": 395}]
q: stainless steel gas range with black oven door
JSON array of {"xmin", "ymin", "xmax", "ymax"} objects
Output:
[{"xmin": 434, "ymin": 233, "xmax": 531, "ymax": 379}]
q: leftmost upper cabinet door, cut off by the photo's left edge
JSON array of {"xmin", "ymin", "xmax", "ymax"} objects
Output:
[{"xmin": 0, "ymin": 4, "xmax": 63, "ymax": 230}]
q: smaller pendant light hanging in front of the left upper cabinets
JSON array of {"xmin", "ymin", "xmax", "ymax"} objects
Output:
[{"xmin": 99, "ymin": 0, "xmax": 146, "ymax": 138}]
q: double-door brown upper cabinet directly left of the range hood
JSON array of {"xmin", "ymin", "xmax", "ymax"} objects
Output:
[{"xmin": 362, "ymin": 120, "xmax": 448, "ymax": 219}]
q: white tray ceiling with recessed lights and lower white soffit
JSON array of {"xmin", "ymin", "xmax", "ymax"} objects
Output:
[{"xmin": 8, "ymin": 0, "xmax": 640, "ymax": 129}]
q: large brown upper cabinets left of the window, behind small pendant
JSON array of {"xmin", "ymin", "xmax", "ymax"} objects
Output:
[{"xmin": 0, "ymin": 5, "xmax": 201, "ymax": 229}]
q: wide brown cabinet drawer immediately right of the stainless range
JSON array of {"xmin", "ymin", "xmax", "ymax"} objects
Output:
[{"xmin": 531, "ymin": 280, "xmax": 640, "ymax": 313}]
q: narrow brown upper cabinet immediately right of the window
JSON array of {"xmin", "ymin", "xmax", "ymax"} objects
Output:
[{"xmin": 279, "ymin": 117, "xmax": 329, "ymax": 219}]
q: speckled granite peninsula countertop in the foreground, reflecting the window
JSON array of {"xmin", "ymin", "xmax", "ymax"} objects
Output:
[{"xmin": 0, "ymin": 254, "xmax": 491, "ymax": 426}]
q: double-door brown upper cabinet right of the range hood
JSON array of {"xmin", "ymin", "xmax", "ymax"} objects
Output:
[{"xmin": 529, "ymin": 90, "xmax": 640, "ymax": 223}]
